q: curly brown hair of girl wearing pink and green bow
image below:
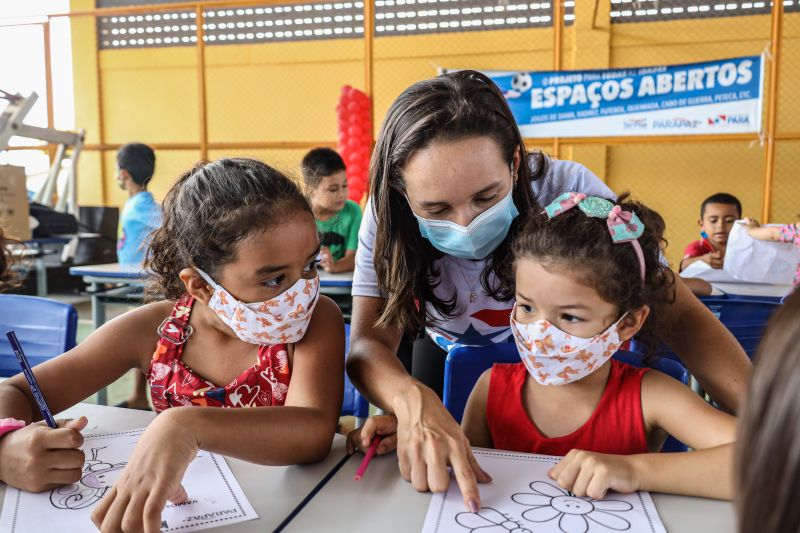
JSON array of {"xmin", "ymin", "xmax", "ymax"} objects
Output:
[{"xmin": 501, "ymin": 194, "xmax": 675, "ymax": 357}]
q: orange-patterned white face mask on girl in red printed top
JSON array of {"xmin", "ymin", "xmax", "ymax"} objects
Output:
[{"xmin": 195, "ymin": 269, "xmax": 319, "ymax": 344}]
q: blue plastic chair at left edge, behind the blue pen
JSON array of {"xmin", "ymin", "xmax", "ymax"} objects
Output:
[{"xmin": 0, "ymin": 294, "xmax": 78, "ymax": 377}]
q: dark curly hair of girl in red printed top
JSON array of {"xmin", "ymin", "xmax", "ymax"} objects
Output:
[{"xmin": 145, "ymin": 158, "xmax": 313, "ymax": 300}]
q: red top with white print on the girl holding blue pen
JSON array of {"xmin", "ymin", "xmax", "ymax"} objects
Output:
[{"xmin": 147, "ymin": 294, "xmax": 291, "ymax": 412}]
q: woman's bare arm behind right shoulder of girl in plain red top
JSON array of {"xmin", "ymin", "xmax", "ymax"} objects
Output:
[{"xmin": 657, "ymin": 276, "xmax": 752, "ymax": 412}]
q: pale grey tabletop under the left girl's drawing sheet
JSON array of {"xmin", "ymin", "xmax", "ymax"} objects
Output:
[{"xmin": 0, "ymin": 403, "xmax": 345, "ymax": 533}]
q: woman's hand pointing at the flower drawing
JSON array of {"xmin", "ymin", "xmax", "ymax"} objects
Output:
[{"xmin": 393, "ymin": 383, "xmax": 492, "ymax": 512}]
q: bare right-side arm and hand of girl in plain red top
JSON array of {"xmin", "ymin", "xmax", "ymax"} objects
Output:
[{"xmin": 551, "ymin": 371, "xmax": 736, "ymax": 500}]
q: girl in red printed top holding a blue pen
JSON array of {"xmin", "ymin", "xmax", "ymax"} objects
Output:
[{"xmin": 0, "ymin": 159, "xmax": 344, "ymax": 531}]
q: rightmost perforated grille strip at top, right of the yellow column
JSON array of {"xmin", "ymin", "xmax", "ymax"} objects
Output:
[{"xmin": 610, "ymin": 0, "xmax": 800, "ymax": 24}]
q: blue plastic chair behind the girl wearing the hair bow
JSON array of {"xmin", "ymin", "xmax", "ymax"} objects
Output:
[{"xmin": 442, "ymin": 343, "xmax": 689, "ymax": 452}]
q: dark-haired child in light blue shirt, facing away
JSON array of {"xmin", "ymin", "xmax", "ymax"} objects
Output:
[{"xmin": 117, "ymin": 143, "xmax": 161, "ymax": 268}]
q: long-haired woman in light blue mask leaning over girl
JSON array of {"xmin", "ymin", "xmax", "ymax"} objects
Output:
[{"xmin": 348, "ymin": 71, "xmax": 750, "ymax": 510}]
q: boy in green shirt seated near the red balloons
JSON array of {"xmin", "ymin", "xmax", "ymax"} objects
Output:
[{"xmin": 302, "ymin": 148, "xmax": 361, "ymax": 273}]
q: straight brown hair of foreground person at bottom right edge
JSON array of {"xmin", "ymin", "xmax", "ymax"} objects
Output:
[{"xmin": 736, "ymin": 291, "xmax": 800, "ymax": 533}]
